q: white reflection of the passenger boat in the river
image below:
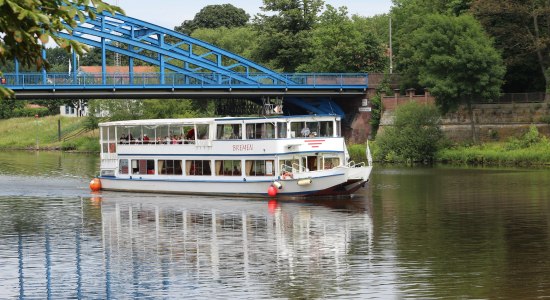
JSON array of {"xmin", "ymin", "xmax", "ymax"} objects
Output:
[{"xmin": 97, "ymin": 194, "xmax": 373, "ymax": 292}]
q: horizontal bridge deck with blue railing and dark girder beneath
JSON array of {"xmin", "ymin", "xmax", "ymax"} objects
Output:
[{"xmin": 4, "ymin": 73, "xmax": 368, "ymax": 99}]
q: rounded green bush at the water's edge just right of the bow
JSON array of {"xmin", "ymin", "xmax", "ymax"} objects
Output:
[{"xmin": 374, "ymin": 102, "xmax": 442, "ymax": 162}]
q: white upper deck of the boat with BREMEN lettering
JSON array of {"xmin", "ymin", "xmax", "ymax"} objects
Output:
[{"xmin": 99, "ymin": 115, "xmax": 343, "ymax": 158}]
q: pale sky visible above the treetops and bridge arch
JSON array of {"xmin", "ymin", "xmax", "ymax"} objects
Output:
[{"xmin": 105, "ymin": 0, "xmax": 391, "ymax": 29}]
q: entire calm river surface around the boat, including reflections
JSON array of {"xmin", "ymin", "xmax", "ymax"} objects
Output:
[{"xmin": 0, "ymin": 152, "xmax": 550, "ymax": 299}]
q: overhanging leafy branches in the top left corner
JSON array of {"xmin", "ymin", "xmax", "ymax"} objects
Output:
[{"xmin": 0, "ymin": 0, "xmax": 122, "ymax": 98}]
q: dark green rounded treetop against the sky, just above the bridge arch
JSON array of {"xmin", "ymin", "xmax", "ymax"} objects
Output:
[{"xmin": 174, "ymin": 4, "xmax": 250, "ymax": 35}]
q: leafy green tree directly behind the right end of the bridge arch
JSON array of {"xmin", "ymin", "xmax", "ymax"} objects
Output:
[{"xmin": 297, "ymin": 5, "xmax": 386, "ymax": 73}]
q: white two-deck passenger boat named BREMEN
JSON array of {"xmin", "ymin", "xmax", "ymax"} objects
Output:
[{"xmin": 90, "ymin": 115, "xmax": 372, "ymax": 198}]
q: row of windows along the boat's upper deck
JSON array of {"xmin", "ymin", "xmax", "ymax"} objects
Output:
[{"xmin": 101, "ymin": 121, "xmax": 340, "ymax": 144}]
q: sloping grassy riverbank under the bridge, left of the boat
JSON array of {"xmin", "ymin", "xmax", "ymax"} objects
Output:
[{"xmin": 0, "ymin": 116, "xmax": 99, "ymax": 151}]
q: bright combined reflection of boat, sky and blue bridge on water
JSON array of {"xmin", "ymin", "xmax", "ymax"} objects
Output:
[{"xmin": 0, "ymin": 194, "xmax": 373, "ymax": 298}]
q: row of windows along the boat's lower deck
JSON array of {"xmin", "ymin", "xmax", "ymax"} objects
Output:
[{"xmin": 118, "ymin": 156, "xmax": 340, "ymax": 176}]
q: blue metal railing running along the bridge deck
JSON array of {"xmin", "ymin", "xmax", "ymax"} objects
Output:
[{"xmin": 3, "ymin": 72, "xmax": 368, "ymax": 88}]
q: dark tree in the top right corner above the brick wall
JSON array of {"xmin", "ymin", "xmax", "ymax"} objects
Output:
[{"xmin": 472, "ymin": 0, "xmax": 550, "ymax": 92}]
